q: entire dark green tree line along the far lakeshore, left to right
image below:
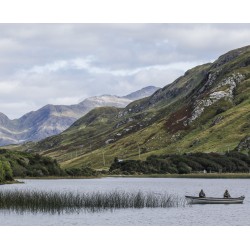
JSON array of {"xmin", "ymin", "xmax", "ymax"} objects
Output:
[{"xmin": 0, "ymin": 149, "xmax": 250, "ymax": 183}]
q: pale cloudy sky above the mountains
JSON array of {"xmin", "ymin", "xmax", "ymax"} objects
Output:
[{"xmin": 0, "ymin": 24, "xmax": 250, "ymax": 119}]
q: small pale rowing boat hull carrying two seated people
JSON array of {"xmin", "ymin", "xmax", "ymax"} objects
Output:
[{"xmin": 185, "ymin": 196, "xmax": 245, "ymax": 204}]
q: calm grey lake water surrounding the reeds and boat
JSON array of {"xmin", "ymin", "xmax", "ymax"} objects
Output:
[{"xmin": 0, "ymin": 178, "xmax": 250, "ymax": 226}]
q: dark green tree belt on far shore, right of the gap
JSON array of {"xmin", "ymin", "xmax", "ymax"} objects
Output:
[{"xmin": 109, "ymin": 151, "xmax": 250, "ymax": 175}]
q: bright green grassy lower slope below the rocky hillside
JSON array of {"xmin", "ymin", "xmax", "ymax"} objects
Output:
[{"xmin": 63, "ymin": 102, "xmax": 250, "ymax": 168}]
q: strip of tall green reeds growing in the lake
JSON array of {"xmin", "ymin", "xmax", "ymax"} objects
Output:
[{"xmin": 0, "ymin": 190, "xmax": 186, "ymax": 214}]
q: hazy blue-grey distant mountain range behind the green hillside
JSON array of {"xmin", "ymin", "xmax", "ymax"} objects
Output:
[{"xmin": 0, "ymin": 86, "xmax": 158, "ymax": 146}]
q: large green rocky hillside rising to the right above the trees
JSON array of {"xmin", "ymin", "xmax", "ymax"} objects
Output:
[{"xmin": 22, "ymin": 46, "xmax": 250, "ymax": 169}]
